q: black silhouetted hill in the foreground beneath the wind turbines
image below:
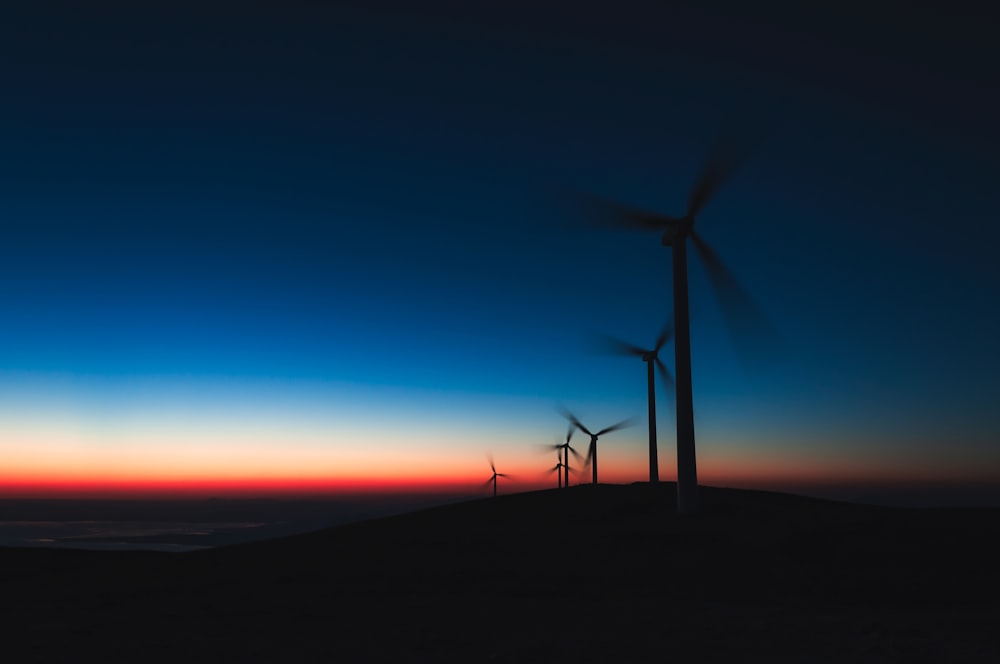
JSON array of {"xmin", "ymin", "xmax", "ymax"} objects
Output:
[{"xmin": 0, "ymin": 483, "xmax": 1000, "ymax": 662}]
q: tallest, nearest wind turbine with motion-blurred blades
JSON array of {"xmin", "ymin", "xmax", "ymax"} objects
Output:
[{"xmin": 588, "ymin": 137, "xmax": 774, "ymax": 514}]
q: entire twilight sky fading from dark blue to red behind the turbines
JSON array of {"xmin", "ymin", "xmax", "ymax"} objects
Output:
[{"xmin": 0, "ymin": 0, "xmax": 1000, "ymax": 503}]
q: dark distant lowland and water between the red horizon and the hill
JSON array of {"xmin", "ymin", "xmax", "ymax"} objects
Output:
[{"xmin": 0, "ymin": 482, "xmax": 1000, "ymax": 552}]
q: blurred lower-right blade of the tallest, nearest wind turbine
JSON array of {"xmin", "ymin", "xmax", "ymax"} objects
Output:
[{"xmin": 691, "ymin": 230, "xmax": 780, "ymax": 360}]
